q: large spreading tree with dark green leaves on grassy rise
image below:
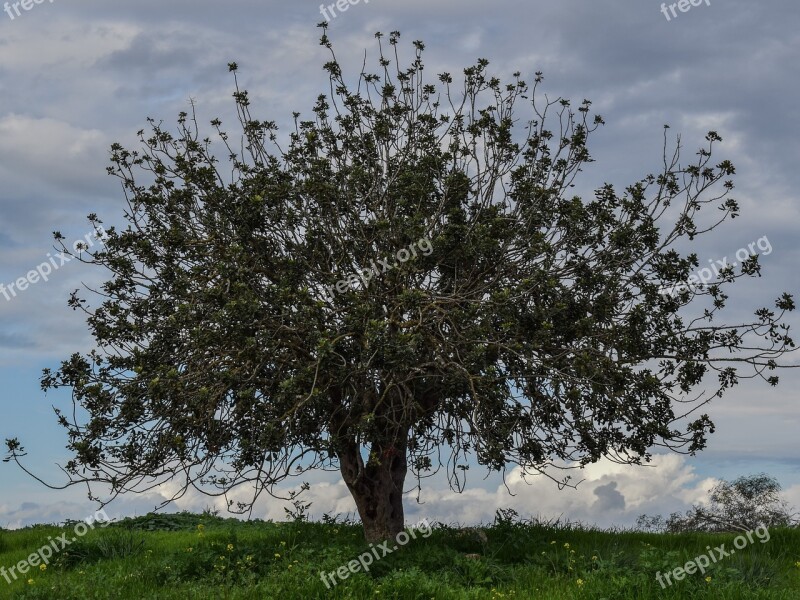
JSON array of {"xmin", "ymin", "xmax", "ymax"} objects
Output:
[{"xmin": 7, "ymin": 23, "xmax": 794, "ymax": 540}]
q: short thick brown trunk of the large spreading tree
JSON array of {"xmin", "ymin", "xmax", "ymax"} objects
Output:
[{"xmin": 339, "ymin": 436, "xmax": 408, "ymax": 542}]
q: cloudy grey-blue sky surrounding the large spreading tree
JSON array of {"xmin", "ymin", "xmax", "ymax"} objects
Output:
[{"xmin": 0, "ymin": 0, "xmax": 800, "ymax": 528}]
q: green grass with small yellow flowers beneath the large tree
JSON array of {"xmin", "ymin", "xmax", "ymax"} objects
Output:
[{"xmin": 0, "ymin": 513, "xmax": 800, "ymax": 600}]
